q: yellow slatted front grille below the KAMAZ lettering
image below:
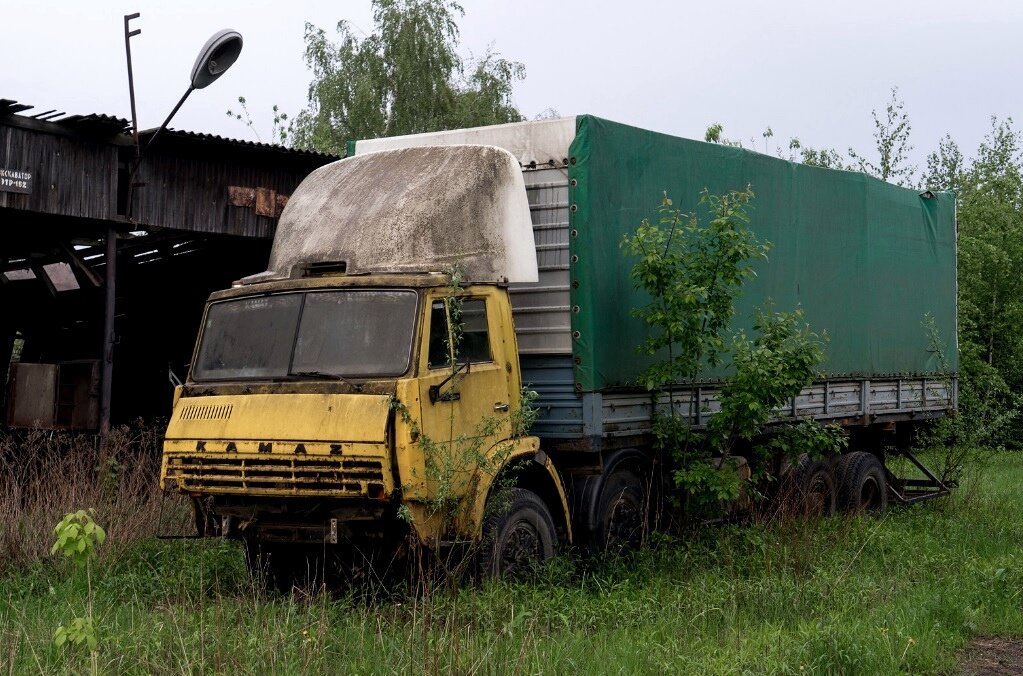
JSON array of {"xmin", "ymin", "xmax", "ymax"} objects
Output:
[{"xmin": 165, "ymin": 453, "xmax": 386, "ymax": 498}]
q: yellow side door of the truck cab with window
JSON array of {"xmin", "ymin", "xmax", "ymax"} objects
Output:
[{"xmin": 419, "ymin": 288, "xmax": 518, "ymax": 481}]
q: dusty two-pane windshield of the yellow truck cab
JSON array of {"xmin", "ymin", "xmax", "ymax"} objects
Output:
[{"xmin": 192, "ymin": 289, "xmax": 416, "ymax": 381}]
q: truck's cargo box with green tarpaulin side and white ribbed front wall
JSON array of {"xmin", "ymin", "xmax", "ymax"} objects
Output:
[{"xmin": 349, "ymin": 116, "xmax": 958, "ymax": 395}]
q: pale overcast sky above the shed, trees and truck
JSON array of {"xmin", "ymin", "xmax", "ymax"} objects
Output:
[{"xmin": 0, "ymin": 0, "xmax": 1023, "ymax": 173}]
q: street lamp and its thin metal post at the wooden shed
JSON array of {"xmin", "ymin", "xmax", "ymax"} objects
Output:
[{"xmin": 99, "ymin": 12, "xmax": 241, "ymax": 450}]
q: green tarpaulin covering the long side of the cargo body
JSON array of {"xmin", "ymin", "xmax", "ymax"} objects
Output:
[{"xmin": 569, "ymin": 116, "xmax": 958, "ymax": 392}]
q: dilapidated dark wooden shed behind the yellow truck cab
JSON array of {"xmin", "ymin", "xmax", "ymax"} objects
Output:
[{"xmin": 0, "ymin": 99, "xmax": 337, "ymax": 431}]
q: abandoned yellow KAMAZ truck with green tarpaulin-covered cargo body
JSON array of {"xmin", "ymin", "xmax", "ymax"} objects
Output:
[{"xmin": 162, "ymin": 116, "xmax": 958, "ymax": 575}]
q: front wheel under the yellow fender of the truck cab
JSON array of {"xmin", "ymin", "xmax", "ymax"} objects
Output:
[{"xmin": 479, "ymin": 488, "xmax": 558, "ymax": 578}]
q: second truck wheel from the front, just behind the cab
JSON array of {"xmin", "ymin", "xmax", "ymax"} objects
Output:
[{"xmin": 593, "ymin": 469, "xmax": 647, "ymax": 555}]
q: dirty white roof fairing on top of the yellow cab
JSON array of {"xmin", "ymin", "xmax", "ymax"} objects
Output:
[{"xmin": 242, "ymin": 145, "xmax": 538, "ymax": 283}]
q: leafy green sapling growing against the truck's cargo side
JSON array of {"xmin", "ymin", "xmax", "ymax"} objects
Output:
[{"xmin": 622, "ymin": 188, "xmax": 838, "ymax": 513}]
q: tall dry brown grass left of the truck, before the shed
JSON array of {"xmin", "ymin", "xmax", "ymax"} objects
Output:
[{"xmin": 0, "ymin": 422, "xmax": 188, "ymax": 572}]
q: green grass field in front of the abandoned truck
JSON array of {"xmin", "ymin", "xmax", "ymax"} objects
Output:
[{"xmin": 0, "ymin": 447, "xmax": 1023, "ymax": 674}]
